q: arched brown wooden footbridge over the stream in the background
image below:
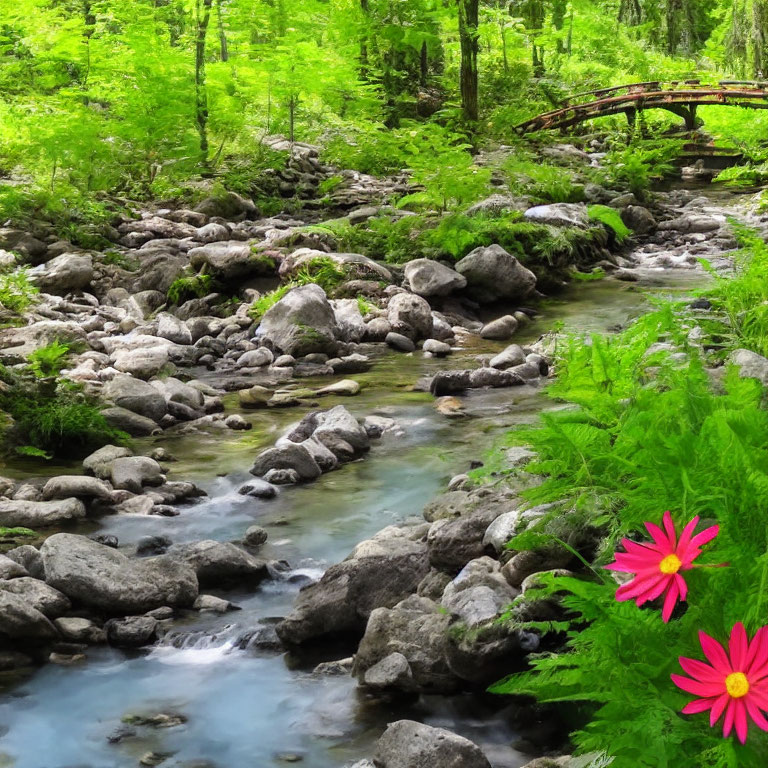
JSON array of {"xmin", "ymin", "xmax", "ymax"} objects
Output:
[{"xmin": 515, "ymin": 80, "xmax": 768, "ymax": 134}]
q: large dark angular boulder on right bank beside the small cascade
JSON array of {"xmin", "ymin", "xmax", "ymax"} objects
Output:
[{"xmin": 277, "ymin": 526, "xmax": 429, "ymax": 644}]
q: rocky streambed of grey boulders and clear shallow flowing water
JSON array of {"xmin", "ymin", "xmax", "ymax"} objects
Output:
[{"xmin": 0, "ymin": 146, "xmax": 760, "ymax": 768}]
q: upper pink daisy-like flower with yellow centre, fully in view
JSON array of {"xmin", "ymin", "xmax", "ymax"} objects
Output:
[{"xmin": 605, "ymin": 512, "xmax": 720, "ymax": 622}]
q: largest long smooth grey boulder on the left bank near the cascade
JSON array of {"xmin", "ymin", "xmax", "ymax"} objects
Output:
[{"xmin": 40, "ymin": 533, "xmax": 198, "ymax": 615}]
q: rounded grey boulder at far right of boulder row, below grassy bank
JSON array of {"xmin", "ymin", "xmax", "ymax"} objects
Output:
[{"xmin": 456, "ymin": 245, "xmax": 536, "ymax": 302}]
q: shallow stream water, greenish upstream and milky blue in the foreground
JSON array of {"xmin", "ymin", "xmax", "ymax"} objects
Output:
[{"xmin": 0, "ymin": 271, "xmax": 706, "ymax": 768}]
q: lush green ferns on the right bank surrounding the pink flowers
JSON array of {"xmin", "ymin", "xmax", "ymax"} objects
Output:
[{"xmin": 493, "ymin": 234, "xmax": 768, "ymax": 768}]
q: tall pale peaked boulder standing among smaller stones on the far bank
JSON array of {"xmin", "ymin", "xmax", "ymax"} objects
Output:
[{"xmin": 257, "ymin": 283, "xmax": 339, "ymax": 357}]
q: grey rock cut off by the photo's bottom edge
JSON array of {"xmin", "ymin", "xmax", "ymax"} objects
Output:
[{"xmin": 373, "ymin": 720, "xmax": 491, "ymax": 768}]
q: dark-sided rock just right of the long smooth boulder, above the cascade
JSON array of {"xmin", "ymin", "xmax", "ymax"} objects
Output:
[{"xmin": 168, "ymin": 541, "xmax": 269, "ymax": 587}]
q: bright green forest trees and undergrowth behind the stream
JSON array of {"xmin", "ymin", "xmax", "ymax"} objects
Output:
[{"xmin": 0, "ymin": 0, "xmax": 768, "ymax": 225}]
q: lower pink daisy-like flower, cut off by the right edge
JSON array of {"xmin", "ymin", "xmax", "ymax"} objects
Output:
[{"xmin": 672, "ymin": 622, "xmax": 768, "ymax": 744}]
